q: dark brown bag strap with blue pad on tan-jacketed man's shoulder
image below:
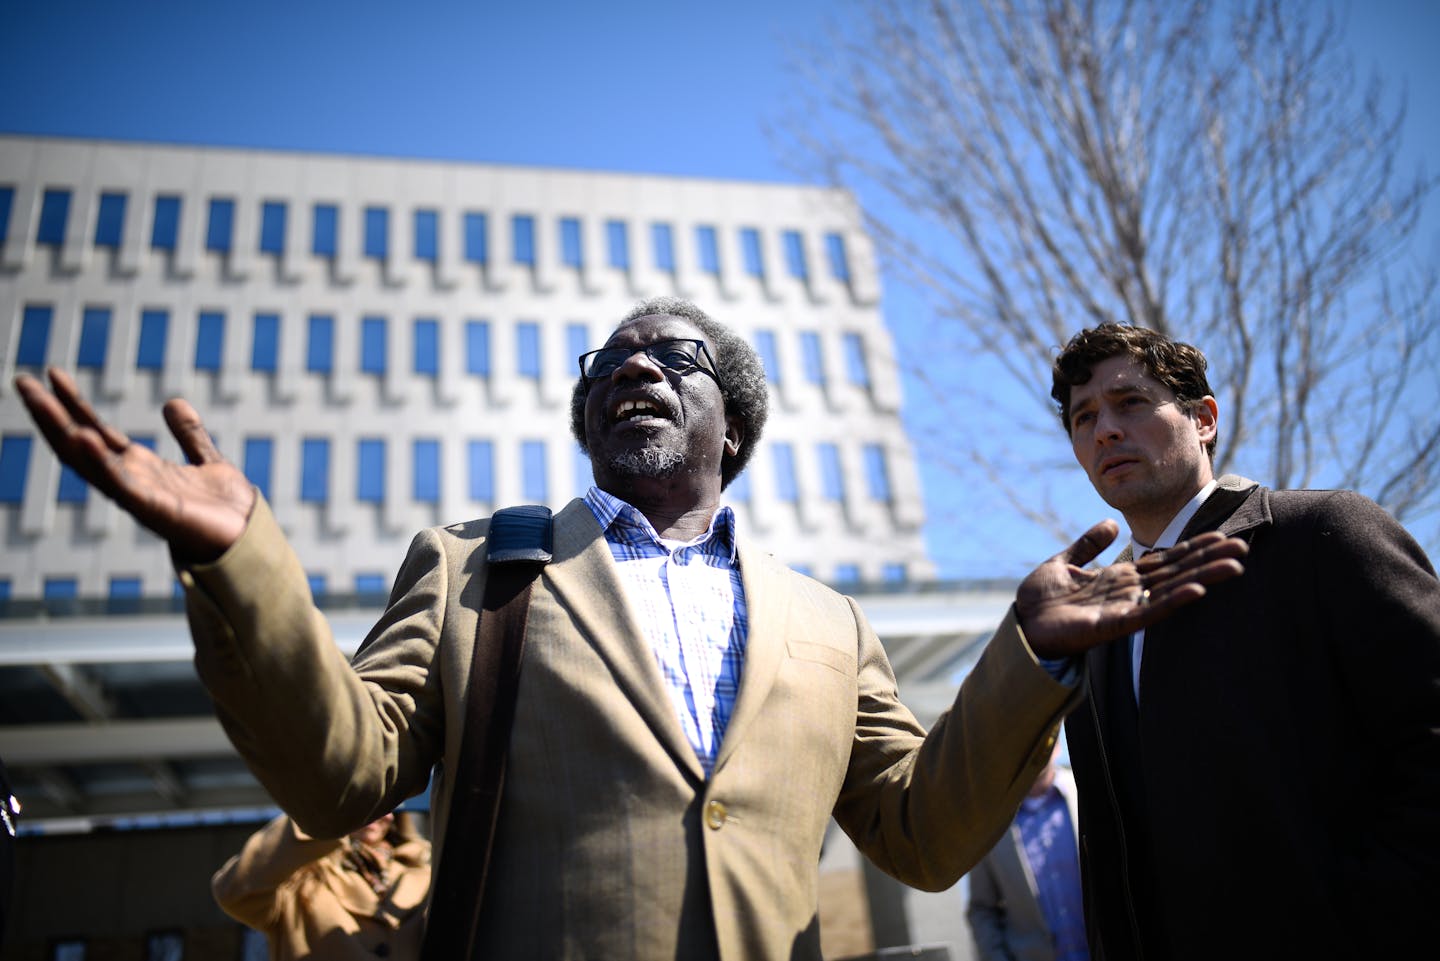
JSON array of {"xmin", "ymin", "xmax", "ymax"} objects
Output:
[{"xmin": 420, "ymin": 504, "xmax": 552, "ymax": 961}]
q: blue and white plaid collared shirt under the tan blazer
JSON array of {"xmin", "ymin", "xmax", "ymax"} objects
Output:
[{"xmin": 585, "ymin": 487, "xmax": 749, "ymax": 777}]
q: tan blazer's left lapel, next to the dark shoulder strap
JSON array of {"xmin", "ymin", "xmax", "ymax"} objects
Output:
[{"xmin": 543, "ymin": 500, "xmax": 704, "ymax": 781}]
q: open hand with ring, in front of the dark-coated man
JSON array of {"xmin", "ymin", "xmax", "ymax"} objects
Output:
[{"xmin": 1015, "ymin": 520, "xmax": 1250, "ymax": 658}]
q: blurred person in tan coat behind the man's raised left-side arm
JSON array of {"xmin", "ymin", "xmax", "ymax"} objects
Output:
[{"xmin": 210, "ymin": 811, "xmax": 431, "ymax": 961}]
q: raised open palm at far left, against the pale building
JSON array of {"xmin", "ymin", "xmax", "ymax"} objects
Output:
[{"xmin": 14, "ymin": 367, "xmax": 255, "ymax": 562}]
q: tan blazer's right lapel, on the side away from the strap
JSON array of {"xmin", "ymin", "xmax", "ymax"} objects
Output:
[{"xmin": 716, "ymin": 546, "xmax": 791, "ymax": 771}]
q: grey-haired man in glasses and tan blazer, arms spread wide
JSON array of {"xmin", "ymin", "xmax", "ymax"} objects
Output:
[{"xmin": 17, "ymin": 300, "xmax": 1243, "ymax": 961}]
